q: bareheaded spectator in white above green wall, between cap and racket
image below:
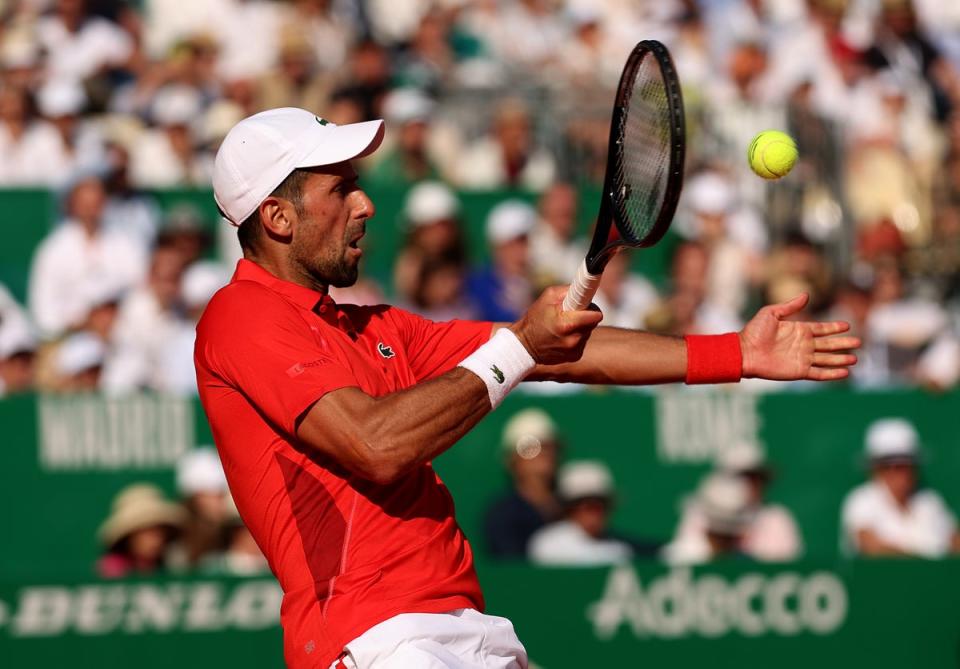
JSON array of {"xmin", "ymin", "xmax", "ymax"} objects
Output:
[{"xmin": 453, "ymin": 99, "xmax": 556, "ymax": 191}]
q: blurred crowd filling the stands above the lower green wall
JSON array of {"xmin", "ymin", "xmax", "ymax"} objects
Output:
[{"xmin": 0, "ymin": 0, "xmax": 960, "ymax": 394}]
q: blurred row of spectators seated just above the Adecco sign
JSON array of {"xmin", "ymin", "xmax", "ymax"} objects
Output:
[{"xmin": 484, "ymin": 409, "xmax": 960, "ymax": 566}]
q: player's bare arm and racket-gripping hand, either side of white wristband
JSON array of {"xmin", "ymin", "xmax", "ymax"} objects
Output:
[{"xmin": 296, "ymin": 288, "xmax": 601, "ymax": 484}]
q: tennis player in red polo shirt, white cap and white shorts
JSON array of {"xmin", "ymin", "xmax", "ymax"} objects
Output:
[{"xmin": 196, "ymin": 108, "xmax": 859, "ymax": 669}]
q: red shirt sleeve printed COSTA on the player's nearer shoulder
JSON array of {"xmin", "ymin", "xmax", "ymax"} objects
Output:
[{"xmin": 195, "ymin": 282, "xmax": 359, "ymax": 436}]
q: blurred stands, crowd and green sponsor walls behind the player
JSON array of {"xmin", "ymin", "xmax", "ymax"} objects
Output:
[{"xmin": 0, "ymin": 0, "xmax": 960, "ymax": 669}]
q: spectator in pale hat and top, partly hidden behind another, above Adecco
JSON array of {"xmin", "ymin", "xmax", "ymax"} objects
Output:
[{"xmin": 674, "ymin": 443, "xmax": 803, "ymax": 562}]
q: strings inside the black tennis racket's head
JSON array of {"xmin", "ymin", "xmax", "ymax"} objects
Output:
[{"xmin": 613, "ymin": 54, "xmax": 673, "ymax": 243}]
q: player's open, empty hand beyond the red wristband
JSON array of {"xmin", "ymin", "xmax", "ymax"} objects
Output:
[{"xmin": 740, "ymin": 293, "xmax": 860, "ymax": 381}]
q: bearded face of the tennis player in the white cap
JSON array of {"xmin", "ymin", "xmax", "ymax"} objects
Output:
[{"xmin": 290, "ymin": 163, "xmax": 374, "ymax": 288}]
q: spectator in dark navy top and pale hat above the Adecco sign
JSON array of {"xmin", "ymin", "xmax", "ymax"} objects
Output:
[{"xmin": 484, "ymin": 409, "xmax": 561, "ymax": 558}]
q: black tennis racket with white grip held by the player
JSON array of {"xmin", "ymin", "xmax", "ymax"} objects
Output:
[{"xmin": 563, "ymin": 40, "xmax": 686, "ymax": 311}]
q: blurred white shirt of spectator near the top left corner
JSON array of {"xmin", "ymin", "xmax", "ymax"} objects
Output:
[{"xmin": 37, "ymin": 15, "xmax": 133, "ymax": 80}]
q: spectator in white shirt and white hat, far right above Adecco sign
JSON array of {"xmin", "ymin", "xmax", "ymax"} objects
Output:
[{"xmin": 841, "ymin": 418, "xmax": 960, "ymax": 558}]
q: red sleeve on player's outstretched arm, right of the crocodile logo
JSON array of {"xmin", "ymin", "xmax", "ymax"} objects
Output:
[{"xmin": 385, "ymin": 308, "xmax": 493, "ymax": 382}]
